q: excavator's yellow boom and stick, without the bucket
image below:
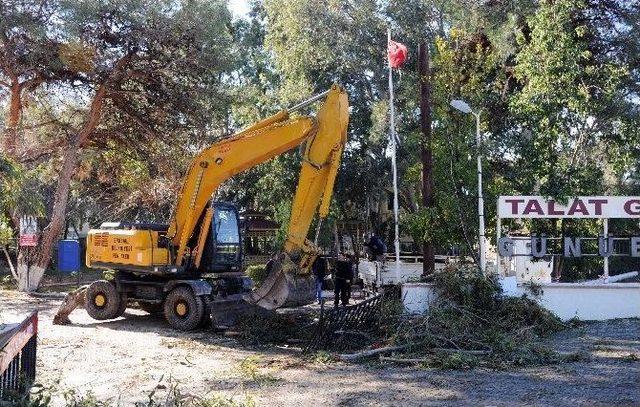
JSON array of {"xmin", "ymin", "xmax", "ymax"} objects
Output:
[{"xmin": 167, "ymin": 85, "xmax": 349, "ymax": 272}]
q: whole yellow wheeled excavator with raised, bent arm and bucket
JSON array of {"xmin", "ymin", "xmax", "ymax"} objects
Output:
[{"xmin": 72, "ymin": 85, "xmax": 349, "ymax": 330}]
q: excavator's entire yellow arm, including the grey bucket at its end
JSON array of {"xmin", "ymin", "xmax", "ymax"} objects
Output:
[{"xmin": 167, "ymin": 85, "xmax": 349, "ymax": 309}]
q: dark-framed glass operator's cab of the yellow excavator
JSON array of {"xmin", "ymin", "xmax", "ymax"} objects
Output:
[{"xmin": 210, "ymin": 202, "xmax": 242, "ymax": 271}]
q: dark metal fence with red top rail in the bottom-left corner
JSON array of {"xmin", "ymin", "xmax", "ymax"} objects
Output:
[{"xmin": 0, "ymin": 311, "xmax": 38, "ymax": 401}]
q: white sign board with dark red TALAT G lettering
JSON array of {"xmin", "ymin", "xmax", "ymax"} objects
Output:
[{"xmin": 498, "ymin": 196, "xmax": 640, "ymax": 219}]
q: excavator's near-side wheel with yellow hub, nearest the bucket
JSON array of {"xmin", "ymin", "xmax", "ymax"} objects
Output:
[{"xmin": 164, "ymin": 286, "xmax": 205, "ymax": 331}]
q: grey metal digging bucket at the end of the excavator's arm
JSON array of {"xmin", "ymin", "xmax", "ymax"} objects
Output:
[{"xmin": 249, "ymin": 253, "xmax": 315, "ymax": 310}]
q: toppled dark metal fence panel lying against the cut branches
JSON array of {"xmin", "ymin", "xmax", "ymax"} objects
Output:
[{"xmin": 304, "ymin": 286, "xmax": 400, "ymax": 352}]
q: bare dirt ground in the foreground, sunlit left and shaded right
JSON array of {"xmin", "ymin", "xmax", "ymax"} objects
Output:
[{"xmin": 0, "ymin": 291, "xmax": 640, "ymax": 407}]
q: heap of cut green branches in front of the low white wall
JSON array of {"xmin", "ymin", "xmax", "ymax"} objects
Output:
[{"xmin": 368, "ymin": 266, "xmax": 565, "ymax": 368}]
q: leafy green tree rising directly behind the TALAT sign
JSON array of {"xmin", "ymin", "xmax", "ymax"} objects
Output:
[{"xmin": 511, "ymin": 0, "xmax": 628, "ymax": 196}]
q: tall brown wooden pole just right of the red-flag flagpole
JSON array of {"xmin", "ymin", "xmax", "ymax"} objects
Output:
[{"xmin": 418, "ymin": 41, "xmax": 435, "ymax": 277}]
